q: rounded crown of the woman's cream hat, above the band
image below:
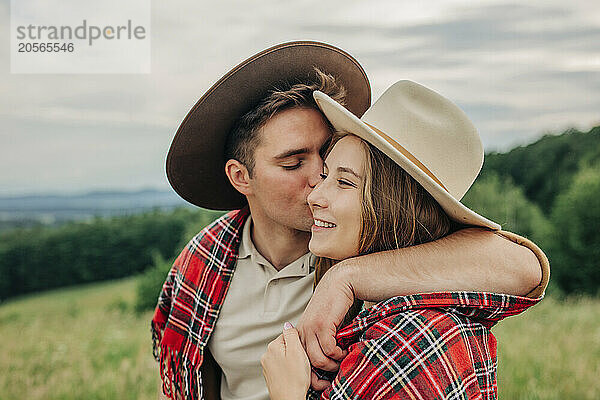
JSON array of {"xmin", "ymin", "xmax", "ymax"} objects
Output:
[{"xmin": 361, "ymin": 80, "xmax": 483, "ymax": 200}]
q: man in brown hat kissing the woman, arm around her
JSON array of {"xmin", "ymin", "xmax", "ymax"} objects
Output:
[{"xmin": 152, "ymin": 42, "xmax": 547, "ymax": 399}]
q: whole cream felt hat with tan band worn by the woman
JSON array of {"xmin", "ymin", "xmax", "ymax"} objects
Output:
[{"xmin": 314, "ymin": 80, "xmax": 500, "ymax": 230}]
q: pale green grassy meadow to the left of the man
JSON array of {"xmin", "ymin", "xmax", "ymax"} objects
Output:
[{"xmin": 0, "ymin": 278, "xmax": 158, "ymax": 400}]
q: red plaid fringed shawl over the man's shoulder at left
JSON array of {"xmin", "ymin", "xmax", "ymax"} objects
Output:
[{"xmin": 151, "ymin": 208, "xmax": 249, "ymax": 399}]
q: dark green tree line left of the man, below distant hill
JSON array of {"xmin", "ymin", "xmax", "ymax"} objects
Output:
[{"xmin": 0, "ymin": 208, "xmax": 223, "ymax": 300}]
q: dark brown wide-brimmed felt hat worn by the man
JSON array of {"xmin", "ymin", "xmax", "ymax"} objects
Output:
[{"xmin": 166, "ymin": 41, "xmax": 371, "ymax": 210}]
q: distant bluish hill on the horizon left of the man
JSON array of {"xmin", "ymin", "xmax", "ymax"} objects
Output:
[{"xmin": 0, "ymin": 189, "xmax": 191, "ymax": 230}]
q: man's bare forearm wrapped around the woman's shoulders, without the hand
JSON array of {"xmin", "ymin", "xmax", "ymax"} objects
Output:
[{"xmin": 336, "ymin": 228, "xmax": 542, "ymax": 302}]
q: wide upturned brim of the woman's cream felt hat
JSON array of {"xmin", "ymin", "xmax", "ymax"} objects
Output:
[{"xmin": 313, "ymin": 91, "xmax": 501, "ymax": 230}]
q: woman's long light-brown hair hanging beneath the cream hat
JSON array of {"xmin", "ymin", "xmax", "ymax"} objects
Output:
[{"xmin": 315, "ymin": 132, "xmax": 453, "ymax": 326}]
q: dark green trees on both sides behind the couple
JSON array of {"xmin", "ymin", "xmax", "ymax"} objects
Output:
[{"xmin": 0, "ymin": 127, "xmax": 600, "ymax": 309}]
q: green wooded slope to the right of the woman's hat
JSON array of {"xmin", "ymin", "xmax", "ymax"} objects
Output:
[{"xmin": 463, "ymin": 126, "xmax": 600, "ymax": 295}]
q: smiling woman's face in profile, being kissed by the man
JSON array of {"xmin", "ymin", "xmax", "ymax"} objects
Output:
[{"xmin": 308, "ymin": 136, "xmax": 367, "ymax": 260}]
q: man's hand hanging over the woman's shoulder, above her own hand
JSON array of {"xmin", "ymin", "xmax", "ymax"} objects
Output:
[{"xmin": 297, "ymin": 267, "xmax": 354, "ymax": 390}]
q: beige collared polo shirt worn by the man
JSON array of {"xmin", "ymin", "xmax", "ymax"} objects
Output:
[{"xmin": 208, "ymin": 217, "xmax": 314, "ymax": 400}]
